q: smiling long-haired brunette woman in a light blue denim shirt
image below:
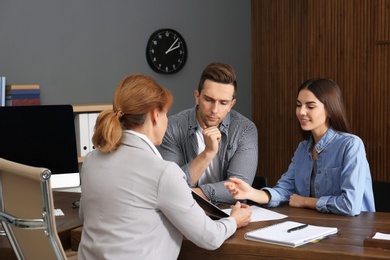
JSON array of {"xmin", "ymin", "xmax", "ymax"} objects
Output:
[{"xmin": 225, "ymin": 78, "xmax": 375, "ymax": 216}]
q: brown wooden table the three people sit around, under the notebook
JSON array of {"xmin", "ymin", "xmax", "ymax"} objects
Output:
[{"xmin": 178, "ymin": 206, "xmax": 390, "ymax": 260}]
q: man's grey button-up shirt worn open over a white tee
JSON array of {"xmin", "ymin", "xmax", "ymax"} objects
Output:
[{"xmin": 158, "ymin": 106, "xmax": 258, "ymax": 204}]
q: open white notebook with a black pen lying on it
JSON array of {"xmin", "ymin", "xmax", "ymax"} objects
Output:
[{"xmin": 244, "ymin": 221, "xmax": 338, "ymax": 247}]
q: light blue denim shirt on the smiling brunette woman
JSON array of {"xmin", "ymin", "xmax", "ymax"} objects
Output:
[{"xmin": 264, "ymin": 128, "xmax": 375, "ymax": 216}]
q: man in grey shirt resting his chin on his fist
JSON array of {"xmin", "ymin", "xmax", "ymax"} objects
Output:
[{"xmin": 158, "ymin": 62, "xmax": 258, "ymax": 204}]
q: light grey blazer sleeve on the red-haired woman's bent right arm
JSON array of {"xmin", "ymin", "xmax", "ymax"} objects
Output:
[{"xmin": 157, "ymin": 162, "xmax": 237, "ymax": 250}]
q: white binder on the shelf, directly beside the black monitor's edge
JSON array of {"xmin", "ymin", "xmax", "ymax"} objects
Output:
[{"xmin": 74, "ymin": 113, "xmax": 90, "ymax": 156}]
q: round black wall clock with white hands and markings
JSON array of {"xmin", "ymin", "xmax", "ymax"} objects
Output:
[{"xmin": 146, "ymin": 29, "xmax": 187, "ymax": 74}]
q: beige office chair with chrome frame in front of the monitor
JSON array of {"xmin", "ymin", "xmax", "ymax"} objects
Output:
[{"xmin": 0, "ymin": 158, "xmax": 77, "ymax": 259}]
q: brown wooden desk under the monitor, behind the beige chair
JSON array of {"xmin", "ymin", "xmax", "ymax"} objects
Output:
[{"xmin": 0, "ymin": 191, "xmax": 82, "ymax": 259}]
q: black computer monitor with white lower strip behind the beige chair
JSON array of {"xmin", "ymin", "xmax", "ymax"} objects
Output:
[{"xmin": 0, "ymin": 105, "xmax": 80, "ymax": 189}]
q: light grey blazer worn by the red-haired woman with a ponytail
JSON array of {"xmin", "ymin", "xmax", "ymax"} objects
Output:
[{"xmin": 78, "ymin": 131, "xmax": 236, "ymax": 260}]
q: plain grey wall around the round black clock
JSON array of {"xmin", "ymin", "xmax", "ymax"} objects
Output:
[{"xmin": 0, "ymin": 0, "xmax": 252, "ymax": 118}]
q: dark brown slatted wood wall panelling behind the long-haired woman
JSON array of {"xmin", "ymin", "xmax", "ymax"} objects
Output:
[{"xmin": 252, "ymin": 0, "xmax": 390, "ymax": 185}]
